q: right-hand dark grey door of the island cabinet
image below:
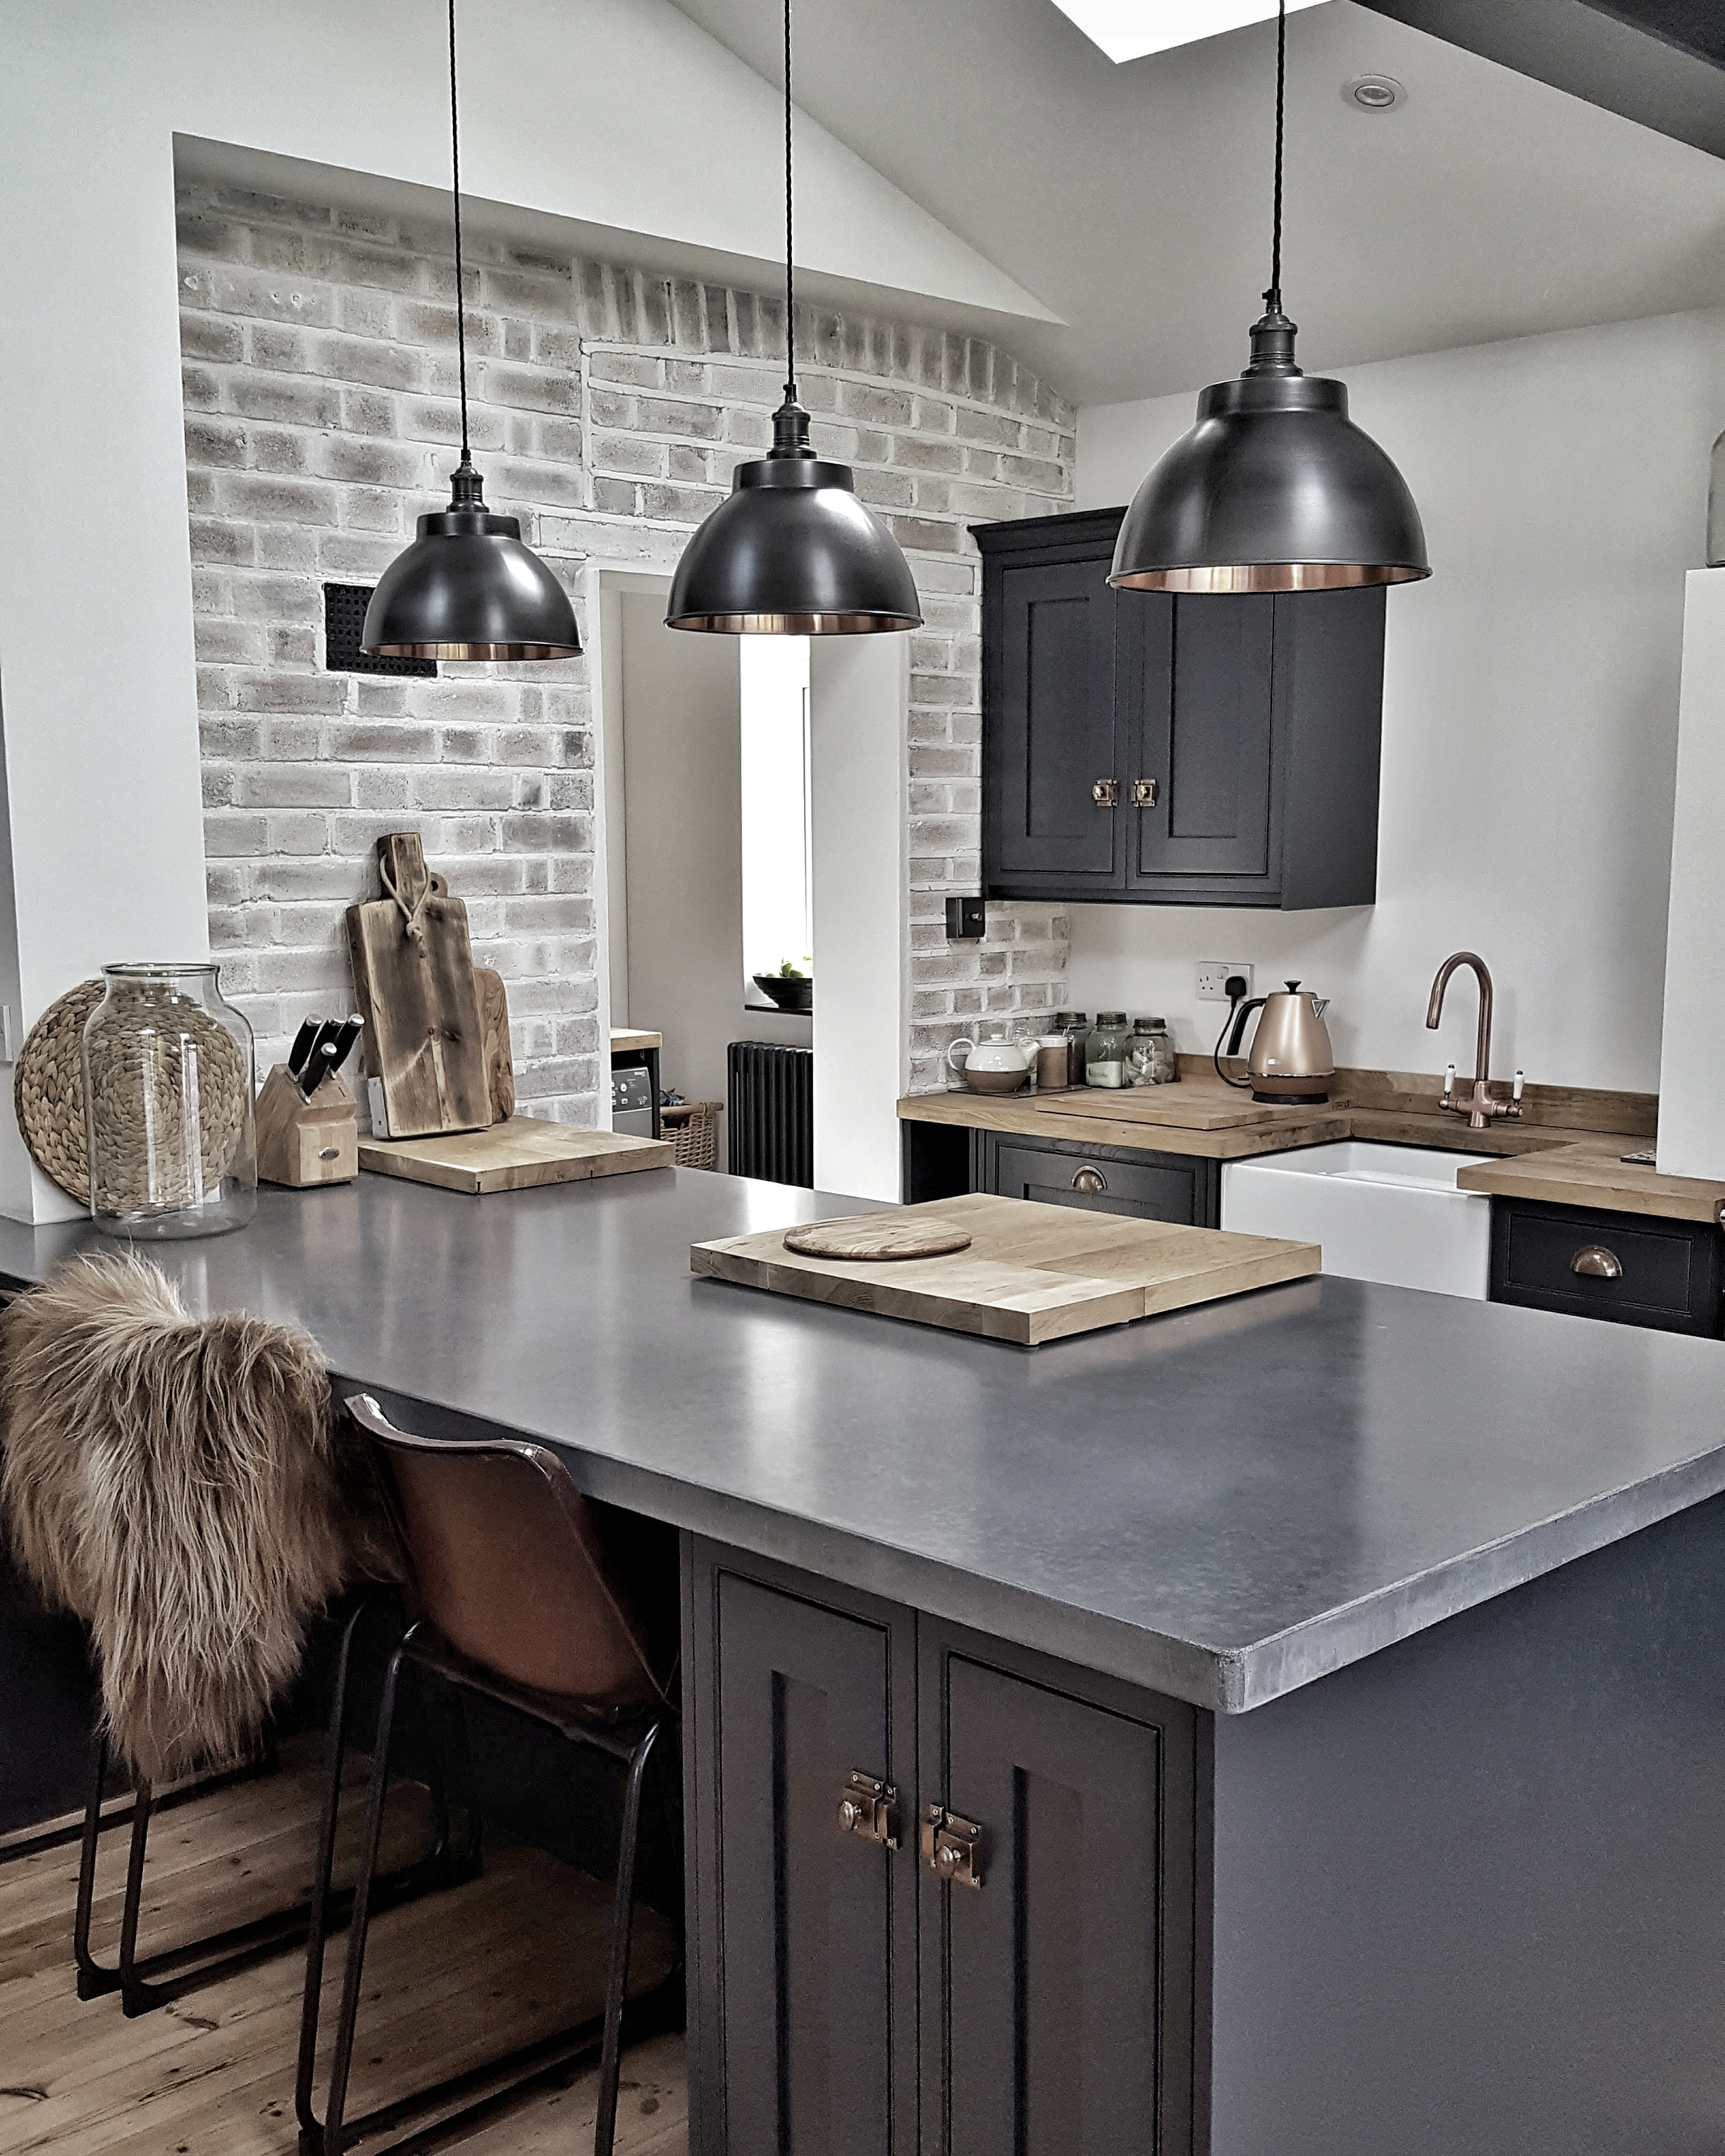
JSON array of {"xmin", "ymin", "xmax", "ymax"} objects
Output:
[{"xmin": 921, "ymin": 1637, "xmax": 1192, "ymax": 2156}]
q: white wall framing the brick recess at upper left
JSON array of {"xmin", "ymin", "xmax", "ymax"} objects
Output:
[{"xmin": 0, "ymin": 0, "xmax": 1041, "ymax": 1218}]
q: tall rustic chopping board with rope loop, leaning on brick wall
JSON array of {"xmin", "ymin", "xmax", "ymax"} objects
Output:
[{"xmin": 347, "ymin": 830, "xmax": 492, "ymax": 1139}]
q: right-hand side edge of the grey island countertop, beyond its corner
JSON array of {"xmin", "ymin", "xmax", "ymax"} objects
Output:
[{"xmin": 1216, "ymin": 1449, "xmax": 1725, "ymax": 1714}]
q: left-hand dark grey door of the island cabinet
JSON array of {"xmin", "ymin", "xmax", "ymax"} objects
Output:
[{"xmin": 718, "ymin": 1574, "xmax": 905, "ymax": 2156}]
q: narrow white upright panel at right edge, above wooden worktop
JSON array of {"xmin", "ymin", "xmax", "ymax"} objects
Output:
[{"xmin": 1658, "ymin": 569, "xmax": 1725, "ymax": 1179}]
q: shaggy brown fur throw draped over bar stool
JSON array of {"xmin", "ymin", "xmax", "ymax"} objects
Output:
[{"xmin": 0, "ymin": 1257, "xmax": 388, "ymax": 1781}]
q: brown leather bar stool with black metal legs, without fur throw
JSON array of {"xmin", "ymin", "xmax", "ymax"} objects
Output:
[{"xmin": 295, "ymin": 1393, "xmax": 679, "ymax": 2156}]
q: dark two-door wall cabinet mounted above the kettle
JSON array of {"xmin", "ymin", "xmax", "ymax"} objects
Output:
[{"xmin": 972, "ymin": 509, "xmax": 1385, "ymax": 907}]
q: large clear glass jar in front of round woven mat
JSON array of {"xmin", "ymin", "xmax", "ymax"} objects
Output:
[{"xmin": 84, "ymin": 966, "xmax": 256, "ymax": 1237}]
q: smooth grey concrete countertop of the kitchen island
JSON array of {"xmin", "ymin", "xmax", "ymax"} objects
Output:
[{"xmin": 0, "ymin": 1169, "xmax": 1725, "ymax": 1712}]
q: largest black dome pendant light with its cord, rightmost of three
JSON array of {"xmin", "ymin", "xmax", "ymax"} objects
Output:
[{"xmin": 1108, "ymin": 0, "xmax": 1432, "ymax": 590}]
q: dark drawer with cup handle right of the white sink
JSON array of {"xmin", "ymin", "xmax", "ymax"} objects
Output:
[{"xmin": 1492, "ymin": 1198, "xmax": 1721, "ymax": 1339}]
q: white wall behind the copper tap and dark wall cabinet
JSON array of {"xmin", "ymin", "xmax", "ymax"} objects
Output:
[{"xmin": 1068, "ymin": 311, "xmax": 1725, "ymax": 1091}]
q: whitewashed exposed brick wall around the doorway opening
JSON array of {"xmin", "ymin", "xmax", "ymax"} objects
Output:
[{"xmin": 179, "ymin": 183, "xmax": 1074, "ymax": 1121}]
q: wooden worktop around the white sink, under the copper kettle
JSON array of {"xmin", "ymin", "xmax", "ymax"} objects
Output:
[{"xmin": 899, "ymin": 1056, "xmax": 1725, "ymax": 1220}]
